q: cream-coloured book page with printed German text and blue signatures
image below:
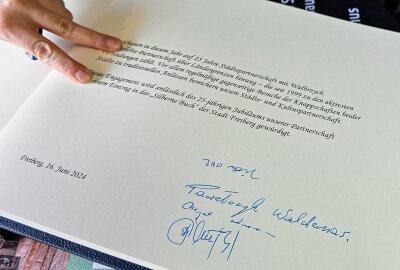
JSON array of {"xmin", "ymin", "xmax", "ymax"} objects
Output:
[{"xmin": 0, "ymin": 0, "xmax": 400, "ymax": 270}]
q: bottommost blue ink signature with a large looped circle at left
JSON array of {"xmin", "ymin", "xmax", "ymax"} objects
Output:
[{"xmin": 167, "ymin": 217, "xmax": 240, "ymax": 261}]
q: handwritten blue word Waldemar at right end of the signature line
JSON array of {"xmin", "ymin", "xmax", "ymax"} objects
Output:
[{"xmin": 272, "ymin": 208, "xmax": 350, "ymax": 242}]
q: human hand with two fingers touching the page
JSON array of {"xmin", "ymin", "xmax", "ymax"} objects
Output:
[{"xmin": 0, "ymin": 0, "xmax": 122, "ymax": 83}]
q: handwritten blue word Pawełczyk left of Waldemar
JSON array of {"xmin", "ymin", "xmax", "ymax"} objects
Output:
[{"xmin": 185, "ymin": 184, "xmax": 266, "ymax": 218}]
